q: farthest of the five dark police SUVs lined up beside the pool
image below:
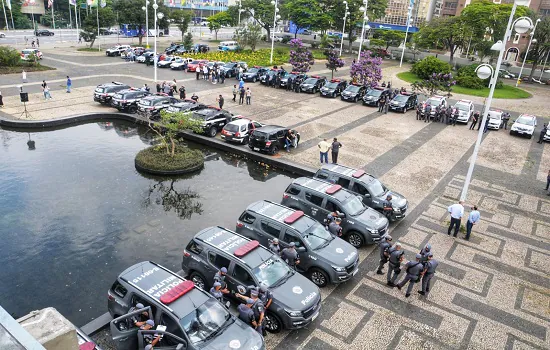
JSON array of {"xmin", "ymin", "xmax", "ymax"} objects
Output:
[{"xmin": 313, "ymin": 164, "xmax": 408, "ymax": 221}]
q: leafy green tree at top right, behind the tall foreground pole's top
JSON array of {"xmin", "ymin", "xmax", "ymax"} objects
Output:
[{"xmin": 460, "ymin": 0, "xmax": 530, "ymax": 45}]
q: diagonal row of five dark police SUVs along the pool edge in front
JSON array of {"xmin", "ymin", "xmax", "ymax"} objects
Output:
[{"xmin": 107, "ymin": 165, "xmax": 407, "ymax": 350}]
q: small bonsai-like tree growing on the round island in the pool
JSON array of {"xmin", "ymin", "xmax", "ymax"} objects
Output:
[{"xmin": 149, "ymin": 111, "xmax": 202, "ymax": 157}]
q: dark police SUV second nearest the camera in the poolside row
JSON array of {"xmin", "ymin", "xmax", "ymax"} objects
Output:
[{"xmin": 181, "ymin": 226, "xmax": 321, "ymax": 334}]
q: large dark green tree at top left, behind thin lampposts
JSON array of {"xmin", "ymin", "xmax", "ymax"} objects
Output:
[{"xmin": 114, "ymin": 0, "xmax": 170, "ymax": 45}]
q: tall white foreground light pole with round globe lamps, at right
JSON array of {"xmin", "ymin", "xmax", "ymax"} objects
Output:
[{"xmin": 460, "ymin": 0, "xmax": 532, "ymax": 201}]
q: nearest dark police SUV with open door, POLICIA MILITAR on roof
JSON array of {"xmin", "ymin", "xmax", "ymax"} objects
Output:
[{"xmin": 107, "ymin": 261, "xmax": 265, "ymax": 350}]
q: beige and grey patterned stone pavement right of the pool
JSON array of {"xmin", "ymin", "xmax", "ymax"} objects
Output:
[{"xmin": 3, "ymin": 52, "xmax": 550, "ymax": 349}]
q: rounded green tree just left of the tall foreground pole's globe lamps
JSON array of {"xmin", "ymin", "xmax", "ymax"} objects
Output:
[{"xmin": 414, "ymin": 16, "xmax": 470, "ymax": 64}]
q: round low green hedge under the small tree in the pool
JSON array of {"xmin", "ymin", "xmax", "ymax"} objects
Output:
[{"xmin": 136, "ymin": 146, "xmax": 204, "ymax": 171}]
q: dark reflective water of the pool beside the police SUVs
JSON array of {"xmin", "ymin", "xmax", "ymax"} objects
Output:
[{"xmin": 0, "ymin": 122, "xmax": 291, "ymax": 325}]
